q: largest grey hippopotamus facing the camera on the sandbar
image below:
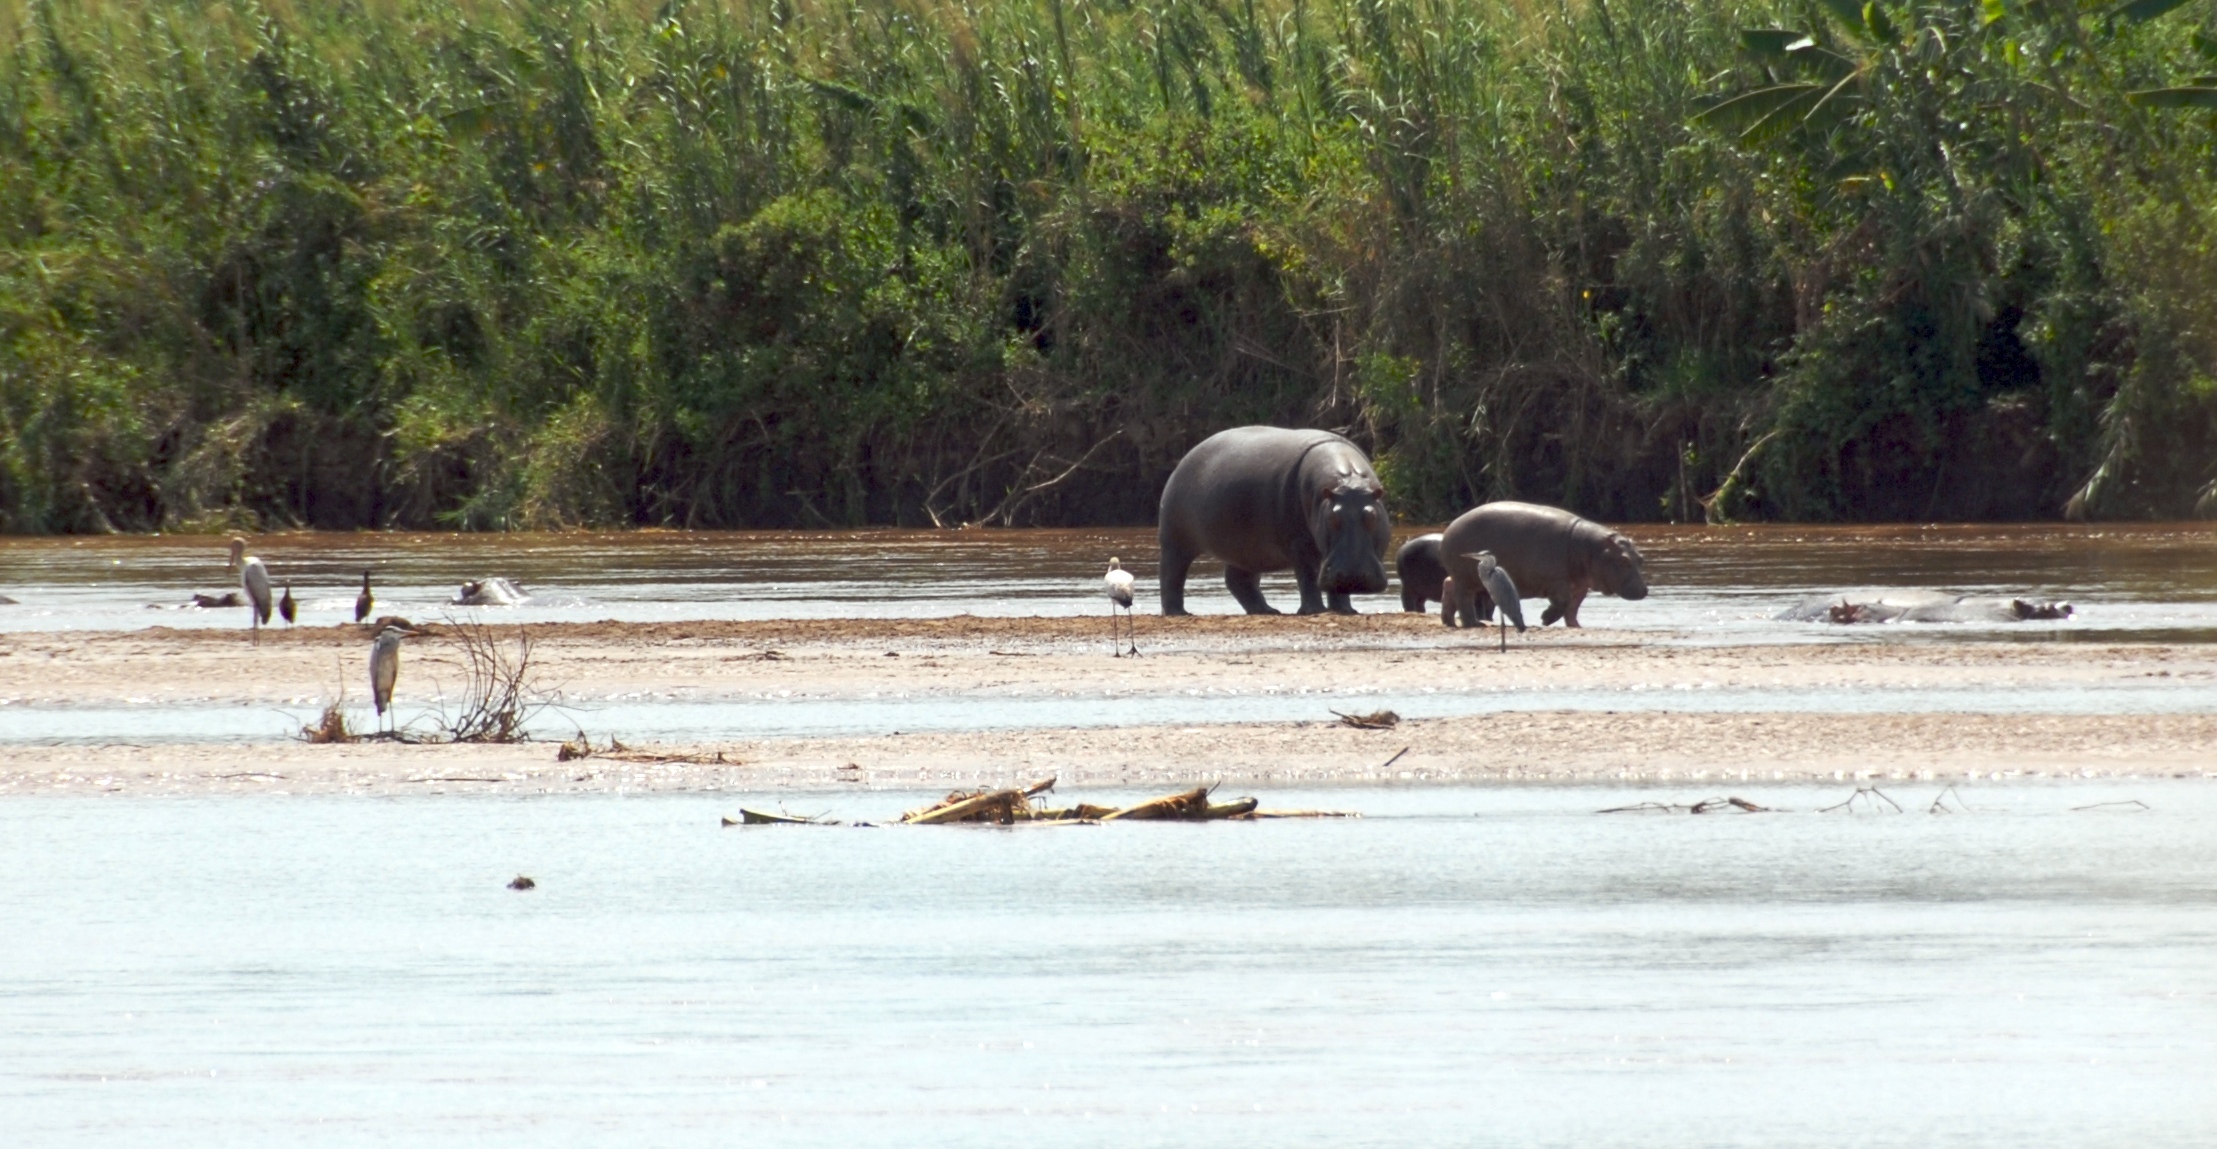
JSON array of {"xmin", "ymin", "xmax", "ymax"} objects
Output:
[{"xmin": 1159, "ymin": 426, "xmax": 1392, "ymax": 614}]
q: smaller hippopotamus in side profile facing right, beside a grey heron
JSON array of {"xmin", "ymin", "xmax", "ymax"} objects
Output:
[{"xmin": 1439, "ymin": 501, "xmax": 1647, "ymax": 626}]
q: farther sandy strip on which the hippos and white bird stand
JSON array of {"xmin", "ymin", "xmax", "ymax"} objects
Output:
[{"xmin": 0, "ymin": 614, "xmax": 2217, "ymax": 705}]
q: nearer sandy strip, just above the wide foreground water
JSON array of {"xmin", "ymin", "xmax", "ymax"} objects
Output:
[{"xmin": 0, "ymin": 712, "xmax": 2217, "ymax": 794}]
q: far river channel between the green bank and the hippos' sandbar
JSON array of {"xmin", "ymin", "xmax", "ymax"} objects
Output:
[{"xmin": 0, "ymin": 523, "xmax": 2217, "ymax": 641}]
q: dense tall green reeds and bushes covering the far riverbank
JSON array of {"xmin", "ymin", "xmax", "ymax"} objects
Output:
[{"xmin": 0, "ymin": 0, "xmax": 2217, "ymax": 532}]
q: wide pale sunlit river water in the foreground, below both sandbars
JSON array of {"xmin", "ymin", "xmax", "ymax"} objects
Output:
[{"xmin": 0, "ymin": 781, "xmax": 2217, "ymax": 1149}]
